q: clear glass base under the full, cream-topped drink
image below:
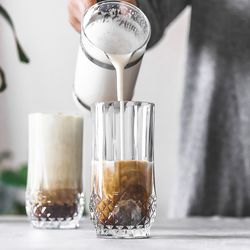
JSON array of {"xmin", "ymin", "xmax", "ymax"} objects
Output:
[{"xmin": 31, "ymin": 218, "xmax": 79, "ymax": 229}]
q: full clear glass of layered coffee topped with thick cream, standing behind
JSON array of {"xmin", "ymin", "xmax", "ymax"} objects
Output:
[{"xmin": 26, "ymin": 113, "xmax": 84, "ymax": 228}]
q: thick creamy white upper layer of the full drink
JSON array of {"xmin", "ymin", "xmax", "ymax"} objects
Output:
[{"xmin": 27, "ymin": 113, "xmax": 83, "ymax": 193}]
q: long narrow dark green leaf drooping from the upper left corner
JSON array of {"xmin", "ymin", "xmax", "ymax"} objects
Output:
[{"xmin": 0, "ymin": 4, "xmax": 29, "ymax": 63}]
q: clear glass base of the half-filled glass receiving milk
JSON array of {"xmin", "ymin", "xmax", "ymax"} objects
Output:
[{"xmin": 96, "ymin": 228, "xmax": 150, "ymax": 239}]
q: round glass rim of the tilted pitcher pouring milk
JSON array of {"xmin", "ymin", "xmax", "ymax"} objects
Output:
[{"xmin": 80, "ymin": 0, "xmax": 151, "ymax": 53}]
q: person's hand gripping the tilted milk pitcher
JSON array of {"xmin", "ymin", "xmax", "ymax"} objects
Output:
[{"xmin": 68, "ymin": 0, "xmax": 136, "ymax": 32}]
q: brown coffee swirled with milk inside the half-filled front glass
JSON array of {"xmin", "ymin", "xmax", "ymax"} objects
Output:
[{"xmin": 91, "ymin": 160, "xmax": 154, "ymax": 229}]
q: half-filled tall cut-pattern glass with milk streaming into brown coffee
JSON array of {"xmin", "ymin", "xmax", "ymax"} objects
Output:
[{"xmin": 90, "ymin": 102, "xmax": 156, "ymax": 238}]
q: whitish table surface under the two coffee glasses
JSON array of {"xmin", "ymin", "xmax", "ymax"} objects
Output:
[{"xmin": 0, "ymin": 217, "xmax": 250, "ymax": 250}]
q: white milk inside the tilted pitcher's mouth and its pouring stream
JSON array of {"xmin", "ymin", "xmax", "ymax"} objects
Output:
[{"xmin": 85, "ymin": 20, "xmax": 145, "ymax": 160}]
